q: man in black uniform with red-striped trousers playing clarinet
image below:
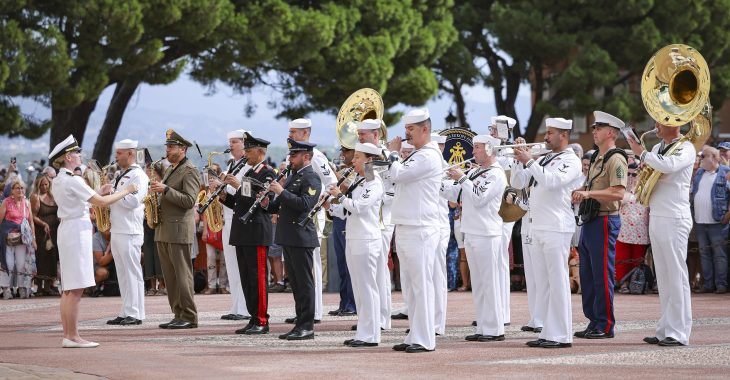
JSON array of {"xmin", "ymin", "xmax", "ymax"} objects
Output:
[{"xmin": 221, "ymin": 132, "xmax": 276, "ymax": 335}]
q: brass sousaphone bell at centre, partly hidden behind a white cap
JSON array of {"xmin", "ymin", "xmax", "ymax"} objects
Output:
[{"xmin": 335, "ymin": 88, "xmax": 388, "ymax": 149}]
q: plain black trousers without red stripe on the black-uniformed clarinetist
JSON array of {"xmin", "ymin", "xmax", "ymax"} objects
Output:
[{"xmin": 282, "ymin": 245, "xmax": 314, "ymax": 330}]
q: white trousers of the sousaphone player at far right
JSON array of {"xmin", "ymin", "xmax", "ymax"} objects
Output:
[{"xmin": 649, "ymin": 215, "xmax": 692, "ymax": 345}]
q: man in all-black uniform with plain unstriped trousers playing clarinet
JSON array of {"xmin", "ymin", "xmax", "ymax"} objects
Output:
[{"xmin": 270, "ymin": 139, "xmax": 322, "ymax": 340}]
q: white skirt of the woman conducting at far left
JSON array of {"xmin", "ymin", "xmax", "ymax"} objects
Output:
[{"xmin": 58, "ymin": 218, "xmax": 96, "ymax": 291}]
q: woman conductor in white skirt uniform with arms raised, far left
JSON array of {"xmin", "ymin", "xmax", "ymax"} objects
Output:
[{"xmin": 48, "ymin": 135, "xmax": 137, "ymax": 348}]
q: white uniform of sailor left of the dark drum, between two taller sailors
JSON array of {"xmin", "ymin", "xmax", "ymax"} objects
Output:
[{"xmin": 443, "ymin": 161, "xmax": 507, "ymax": 336}]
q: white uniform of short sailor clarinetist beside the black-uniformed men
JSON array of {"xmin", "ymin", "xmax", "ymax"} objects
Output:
[{"xmin": 330, "ymin": 176, "xmax": 383, "ymax": 343}]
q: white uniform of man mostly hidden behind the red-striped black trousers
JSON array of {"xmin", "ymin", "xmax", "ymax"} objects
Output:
[{"xmin": 222, "ymin": 157, "xmax": 251, "ymax": 317}]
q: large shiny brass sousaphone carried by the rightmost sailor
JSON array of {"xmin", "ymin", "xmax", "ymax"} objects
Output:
[{"xmin": 635, "ymin": 44, "xmax": 712, "ymax": 206}]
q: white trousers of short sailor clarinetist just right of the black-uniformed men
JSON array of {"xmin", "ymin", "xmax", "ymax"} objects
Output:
[{"xmin": 345, "ymin": 239, "xmax": 381, "ymax": 343}]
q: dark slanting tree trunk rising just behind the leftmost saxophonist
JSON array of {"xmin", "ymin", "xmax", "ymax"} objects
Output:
[{"xmin": 92, "ymin": 79, "xmax": 140, "ymax": 165}]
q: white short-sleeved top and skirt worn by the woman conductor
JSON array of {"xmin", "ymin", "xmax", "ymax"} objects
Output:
[{"xmin": 51, "ymin": 168, "xmax": 96, "ymax": 291}]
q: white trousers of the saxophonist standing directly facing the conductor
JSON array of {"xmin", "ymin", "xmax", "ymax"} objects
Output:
[{"xmin": 111, "ymin": 233, "xmax": 145, "ymax": 320}]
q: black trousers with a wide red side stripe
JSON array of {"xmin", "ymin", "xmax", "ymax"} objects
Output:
[{"xmin": 236, "ymin": 245, "xmax": 269, "ymax": 326}]
